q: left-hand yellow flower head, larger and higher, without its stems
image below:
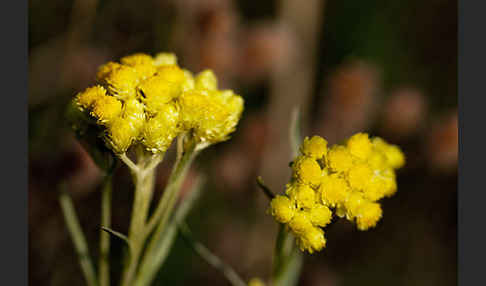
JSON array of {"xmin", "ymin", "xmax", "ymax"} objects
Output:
[{"xmin": 74, "ymin": 53, "xmax": 243, "ymax": 153}]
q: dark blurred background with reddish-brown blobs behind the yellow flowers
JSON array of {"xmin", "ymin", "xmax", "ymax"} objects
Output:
[{"xmin": 28, "ymin": 0, "xmax": 458, "ymax": 286}]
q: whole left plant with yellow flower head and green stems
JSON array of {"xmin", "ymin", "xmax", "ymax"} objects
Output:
[{"xmin": 60, "ymin": 53, "xmax": 243, "ymax": 286}]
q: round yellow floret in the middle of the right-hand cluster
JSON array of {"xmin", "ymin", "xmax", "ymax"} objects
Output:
[{"xmin": 319, "ymin": 174, "xmax": 349, "ymax": 207}]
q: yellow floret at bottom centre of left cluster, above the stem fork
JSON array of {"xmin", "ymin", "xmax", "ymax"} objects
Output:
[{"xmin": 142, "ymin": 104, "xmax": 180, "ymax": 153}]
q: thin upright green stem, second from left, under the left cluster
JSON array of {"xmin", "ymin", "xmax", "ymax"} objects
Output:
[{"xmin": 98, "ymin": 172, "xmax": 112, "ymax": 286}]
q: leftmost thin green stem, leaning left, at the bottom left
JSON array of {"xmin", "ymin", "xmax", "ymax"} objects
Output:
[{"xmin": 59, "ymin": 186, "xmax": 98, "ymax": 286}]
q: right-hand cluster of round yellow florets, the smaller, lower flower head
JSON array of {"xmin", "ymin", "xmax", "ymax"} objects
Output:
[{"xmin": 270, "ymin": 133, "xmax": 405, "ymax": 253}]
